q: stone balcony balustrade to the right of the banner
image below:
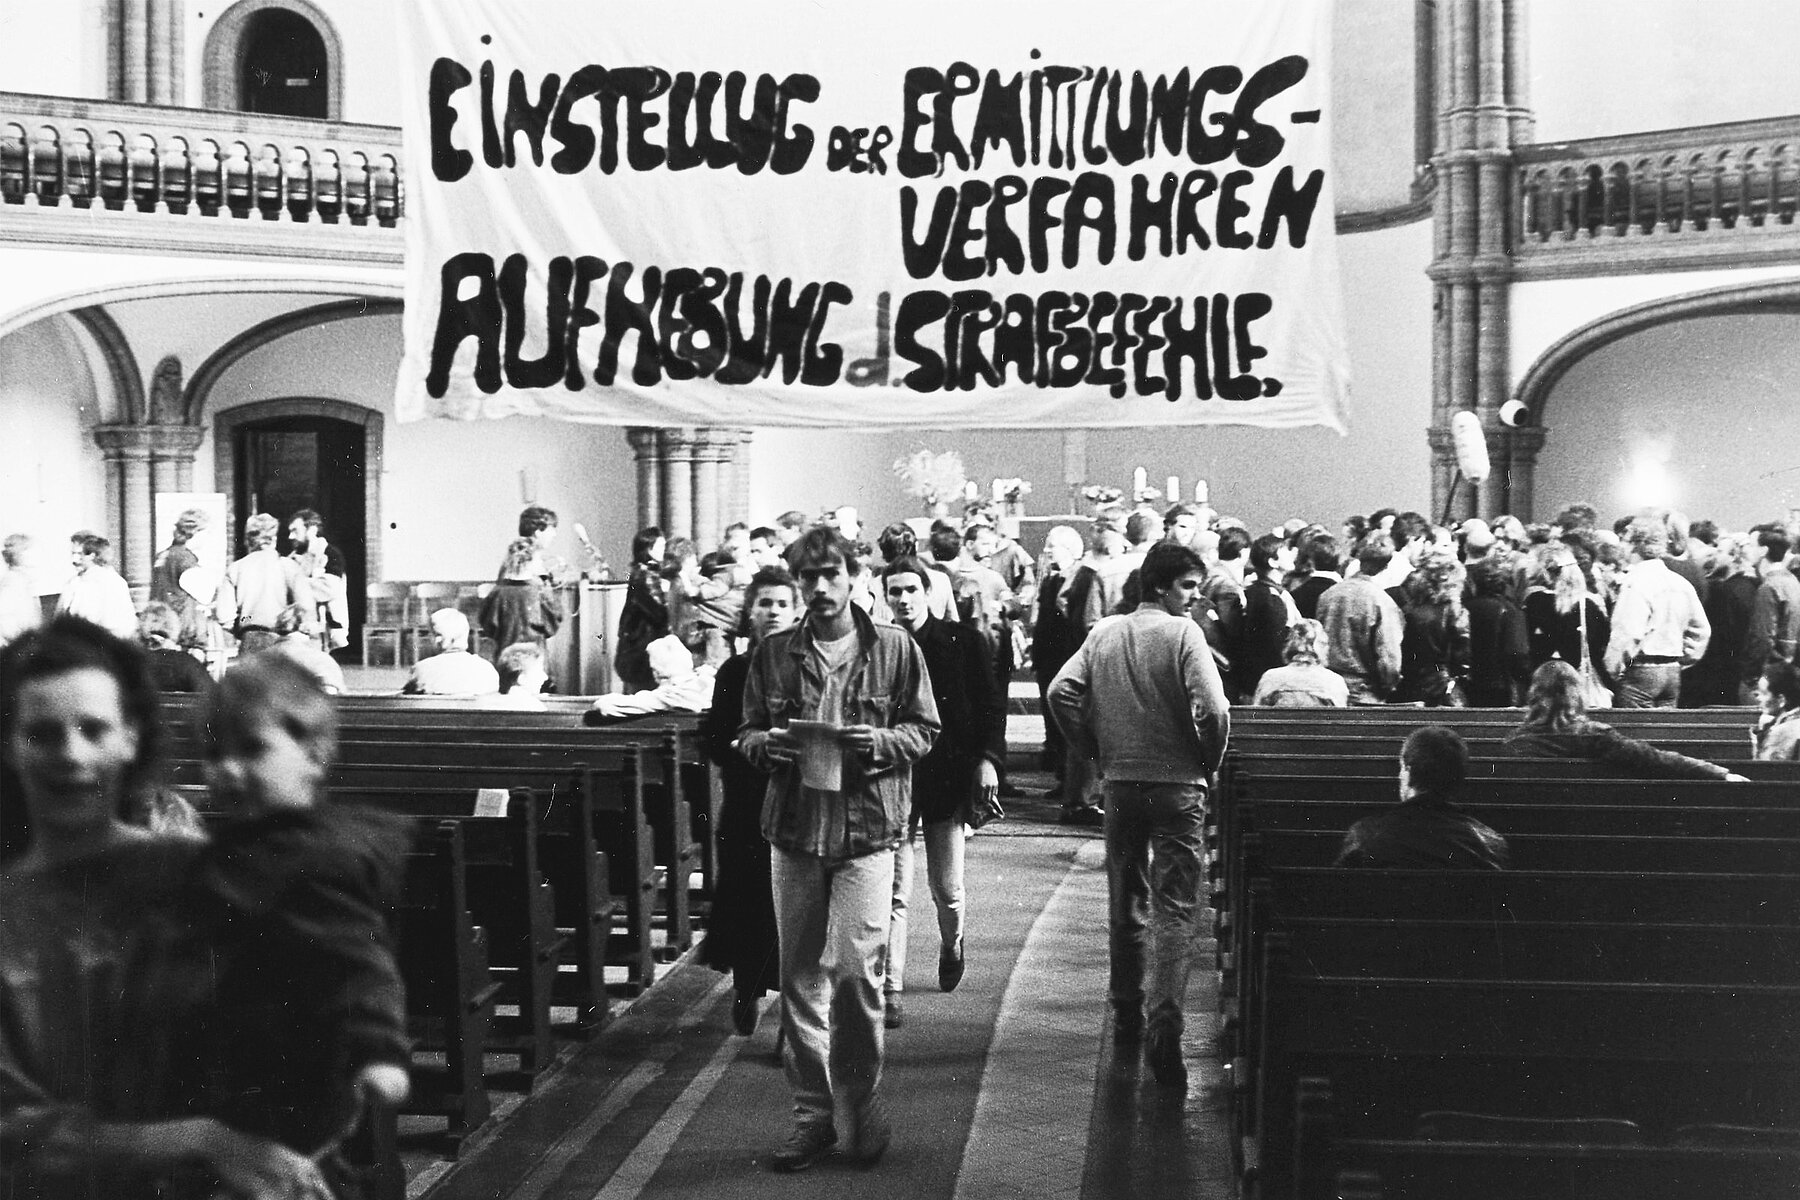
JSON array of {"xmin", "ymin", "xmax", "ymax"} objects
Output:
[{"xmin": 1514, "ymin": 117, "xmax": 1800, "ymax": 275}]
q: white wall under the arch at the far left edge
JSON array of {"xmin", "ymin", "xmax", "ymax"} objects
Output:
[{"xmin": 0, "ymin": 317, "xmax": 106, "ymax": 575}]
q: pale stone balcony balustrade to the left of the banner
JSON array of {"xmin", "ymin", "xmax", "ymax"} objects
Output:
[{"xmin": 0, "ymin": 92, "xmax": 405, "ymax": 228}]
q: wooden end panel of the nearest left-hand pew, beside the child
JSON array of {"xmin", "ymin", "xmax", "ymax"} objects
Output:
[{"xmin": 396, "ymin": 820, "xmax": 500, "ymax": 1157}]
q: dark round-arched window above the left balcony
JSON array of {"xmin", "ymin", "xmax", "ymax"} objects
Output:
[{"xmin": 203, "ymin": 0, "xmax": 344, "ymax": 121}]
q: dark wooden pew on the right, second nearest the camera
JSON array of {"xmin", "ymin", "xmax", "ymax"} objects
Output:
[{"xmin": 1247, "ymin": 945, "xmax": 1800, "ymax": 1200}]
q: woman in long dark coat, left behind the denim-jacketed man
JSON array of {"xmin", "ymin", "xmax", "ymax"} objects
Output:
[{"xmin": 700, "ymin": 567, "xmax": 799, "ymax": 1036}]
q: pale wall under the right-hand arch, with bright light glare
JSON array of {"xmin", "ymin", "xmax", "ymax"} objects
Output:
[{"xmin": 1537, "ymin": 313, "xmax": 1800, "ymax": 529}]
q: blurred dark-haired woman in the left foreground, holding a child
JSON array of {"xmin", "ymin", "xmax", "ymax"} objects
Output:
[{"xmin": 0, "ymin": 617, "xmax": 333, "ymax": 1200}]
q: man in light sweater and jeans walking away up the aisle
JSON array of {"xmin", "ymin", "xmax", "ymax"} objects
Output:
[{"xmin": 1049, "ymin": 542, "xmax": 1231, "ymax": 1088}]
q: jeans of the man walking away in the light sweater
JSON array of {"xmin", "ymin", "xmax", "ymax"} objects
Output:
[{"xmin": 1105, "ymin": 779, "xmax": 1206, "ymax": 1034}]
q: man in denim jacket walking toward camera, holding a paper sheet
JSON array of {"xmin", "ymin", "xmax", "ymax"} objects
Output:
[{"xmin": 738, "ymin": 527, "xmax": 938, "ymax": 1171}]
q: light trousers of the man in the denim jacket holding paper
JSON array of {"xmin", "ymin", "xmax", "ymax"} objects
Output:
[{"xmin": 769, "ymin": 847, "xmax": 895, "ymax": 1124}]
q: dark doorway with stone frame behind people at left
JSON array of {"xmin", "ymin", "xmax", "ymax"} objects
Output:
[{"xmin": 212, "ymin": 399, "xmax": 382, "ymax": 648}]
